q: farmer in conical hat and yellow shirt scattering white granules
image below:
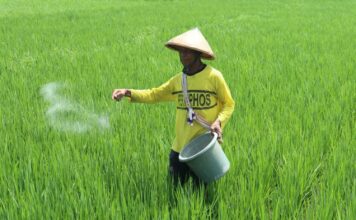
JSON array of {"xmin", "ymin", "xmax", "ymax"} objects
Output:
[{"xmin": 112, "ymin": 28, "xmax": 235, "ymax": 186}]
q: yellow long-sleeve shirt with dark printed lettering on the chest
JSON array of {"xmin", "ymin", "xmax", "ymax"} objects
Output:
[{"xmin": 131, "ymin": 65, "xmax": 235, "ymax": 152}]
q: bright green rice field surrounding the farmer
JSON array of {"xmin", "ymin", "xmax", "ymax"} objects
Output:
[{"xmin": 0, "ymin": 0, "xmax": 356, "ymax": 219}]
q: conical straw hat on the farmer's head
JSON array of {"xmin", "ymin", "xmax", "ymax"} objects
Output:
[{"xmin": 166, "ymin": 28, "xmax": 215, "ymax": 60}]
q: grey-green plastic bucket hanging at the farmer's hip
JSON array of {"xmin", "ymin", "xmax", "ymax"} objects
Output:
[{"xmin": 179, "ymin": 132, "xmax": 230, "ymax": 183}]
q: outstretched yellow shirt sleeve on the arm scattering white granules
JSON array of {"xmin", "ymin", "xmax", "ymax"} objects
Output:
[{"xmin": 130, "ymin": 77, "xmax": 174, "ymax": 103}]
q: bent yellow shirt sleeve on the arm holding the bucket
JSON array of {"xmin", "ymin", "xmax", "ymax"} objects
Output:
[{"xmin": 216, "ymin": 73, "xmax": 235, "ymax": 128}]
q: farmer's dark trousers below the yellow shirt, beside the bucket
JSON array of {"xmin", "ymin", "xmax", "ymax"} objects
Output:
[{"xmin": 169, "ymin": 150, "xmax": 203, "ymax": 186}]
